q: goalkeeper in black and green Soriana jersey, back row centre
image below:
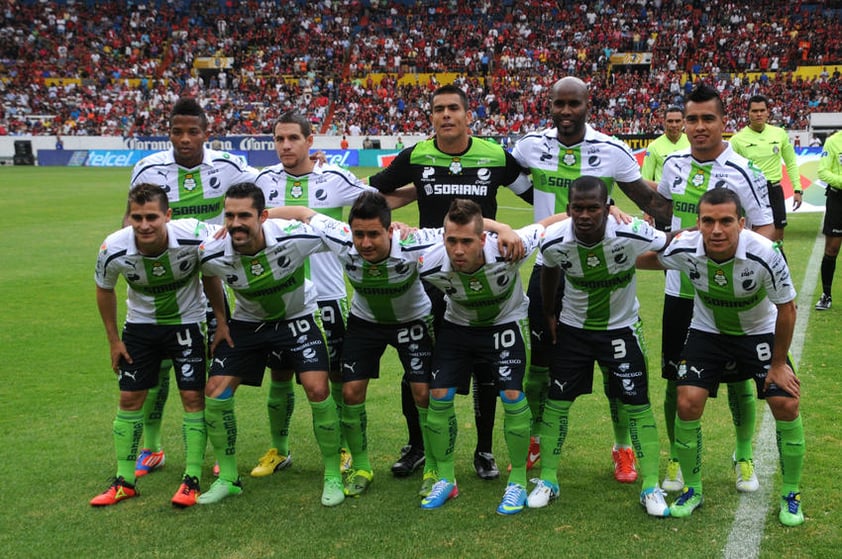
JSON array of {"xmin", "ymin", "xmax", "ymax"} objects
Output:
[{"xmin": 369, "ymin": 85, "xmax": 532, "ymax": 479}]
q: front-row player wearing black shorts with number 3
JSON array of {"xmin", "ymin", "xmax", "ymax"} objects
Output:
[{"xmin": 528, "ymin": 176, "xmax": 669, "ymax": 517}]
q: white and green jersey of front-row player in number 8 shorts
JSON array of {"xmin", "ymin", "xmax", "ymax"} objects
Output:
[{"xmin": 658, "ymin": 229, "xmax": 795, "ymax": 336}]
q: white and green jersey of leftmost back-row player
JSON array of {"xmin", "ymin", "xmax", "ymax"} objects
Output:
[{"xmin": 130, "ymin": 148, "xmax": 257, "ymax": 224}]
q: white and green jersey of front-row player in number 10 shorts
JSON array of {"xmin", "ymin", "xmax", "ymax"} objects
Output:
[{"xmin": 421, "ymin": 224, "xmax": 544, "ymax": 326}]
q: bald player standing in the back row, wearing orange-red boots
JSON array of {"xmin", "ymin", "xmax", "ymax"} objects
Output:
[{"xmin": 512, "ymin": 77, "xmax": 669, "ymax": 483}]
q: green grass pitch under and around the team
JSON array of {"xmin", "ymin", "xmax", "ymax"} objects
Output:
[{"xmin": 0, "ymin": 167, "xmax": 842, "ymax": 559}]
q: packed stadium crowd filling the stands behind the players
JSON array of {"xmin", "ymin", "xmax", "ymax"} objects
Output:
[{"xmin": 0, "ymin": 0, "xmax": 842, "ymax": 136}]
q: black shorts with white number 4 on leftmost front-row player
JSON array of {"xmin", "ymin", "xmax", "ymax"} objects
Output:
[{"xmin": 119, "ymin": 323, "xmax": 207, "ymax": 392}]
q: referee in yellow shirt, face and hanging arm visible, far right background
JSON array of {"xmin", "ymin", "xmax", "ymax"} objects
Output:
[{"xmin": 730, "ymin": 95, "xmax": 802, "ymax": 246}]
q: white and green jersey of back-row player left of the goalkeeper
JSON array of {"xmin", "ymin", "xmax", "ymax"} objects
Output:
[{"xmin": 255, "ymin": 164, "xmax": 377, "ymax": 301}]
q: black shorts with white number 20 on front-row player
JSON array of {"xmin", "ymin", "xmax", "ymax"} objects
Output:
[{"xmin": 342, "ymin": 314, "xmax": 435, "ymax": 383}]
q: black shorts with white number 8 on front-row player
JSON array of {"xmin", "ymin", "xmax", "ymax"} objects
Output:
[{"xmin": 676, "ymin": 328, "xmax": 792, "ymax": 399}]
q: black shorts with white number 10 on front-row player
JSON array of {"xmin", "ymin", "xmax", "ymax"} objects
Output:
[{"xmin": 430, "ymin": 319, "xmax": 529, "ymax": 391}]
